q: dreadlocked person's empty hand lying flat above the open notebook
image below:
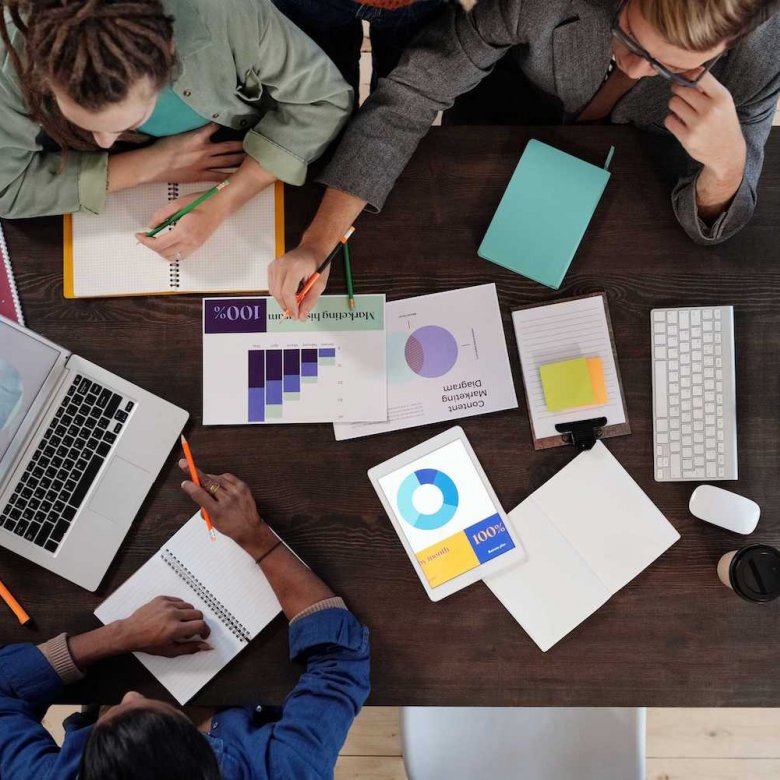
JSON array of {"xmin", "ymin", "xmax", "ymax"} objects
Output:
[{"xmin": 149, "ymin": 123, "xmax": 246, "ymax": 183}]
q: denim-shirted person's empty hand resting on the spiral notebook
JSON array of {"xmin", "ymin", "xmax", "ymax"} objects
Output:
[{"xmin": 114, "ymin": 596, "xmax": 211, "ymax": 658}]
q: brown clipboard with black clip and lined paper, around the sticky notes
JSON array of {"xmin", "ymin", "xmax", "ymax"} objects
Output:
[{"xmin": 512, "ymin": 292, "xmax": 631, "ymax": 450}]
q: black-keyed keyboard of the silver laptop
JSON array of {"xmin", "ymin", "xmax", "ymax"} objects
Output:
[{"xmin": 0, "ymin": 375, "xmax": 134, "ymax": 553}]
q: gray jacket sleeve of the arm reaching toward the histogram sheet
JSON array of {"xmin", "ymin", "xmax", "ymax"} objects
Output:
[{"xmin": 319, "ymin": 0, "xmax": 523, "ymax": 211}]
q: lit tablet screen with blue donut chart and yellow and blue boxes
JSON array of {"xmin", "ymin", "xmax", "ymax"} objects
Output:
[{"xmin": 379, "ymin": 441, "xmax": 515, "ymax": 588}]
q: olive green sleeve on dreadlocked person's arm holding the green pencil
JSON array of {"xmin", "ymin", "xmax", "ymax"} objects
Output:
[{"xmin": 244, "ymin": 1, "xmax": 353, "ymax": 184}]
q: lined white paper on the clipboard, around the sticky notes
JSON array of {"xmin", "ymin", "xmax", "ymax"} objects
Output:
[{"xmin": 512, "ymin": 295, "xmax": 626, "ymax": 439}]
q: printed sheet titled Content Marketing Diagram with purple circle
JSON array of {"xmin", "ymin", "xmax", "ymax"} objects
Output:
[{"xmin": 334, "ymin": 284, "xmax": 517, "ymax": 440}]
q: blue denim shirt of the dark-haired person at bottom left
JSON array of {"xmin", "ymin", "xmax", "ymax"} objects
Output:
[{"xmin": 0, "ymin": 608, "xmax": 369, "ymax": 780}]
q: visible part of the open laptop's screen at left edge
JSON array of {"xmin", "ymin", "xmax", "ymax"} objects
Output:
[{"xmin": 0, "ymin": 322, "xmax": 61, "ymax": 459}]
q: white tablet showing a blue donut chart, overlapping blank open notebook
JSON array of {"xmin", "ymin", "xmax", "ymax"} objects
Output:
[{"xmin": 368, "ymin": 427, "xmax": 524, "ymax": 601}]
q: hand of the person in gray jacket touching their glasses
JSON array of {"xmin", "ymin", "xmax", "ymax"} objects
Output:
[{"xmin": 664, "ymin": 73, "xmax": 746, "ymax": 185}]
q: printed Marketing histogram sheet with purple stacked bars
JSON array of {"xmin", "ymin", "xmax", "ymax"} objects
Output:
[{"xmin": 203, "ymin": 295, "xmax": 387, "ymax": 425}]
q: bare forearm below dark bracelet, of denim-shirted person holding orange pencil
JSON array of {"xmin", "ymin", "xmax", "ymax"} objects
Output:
[{"xmin": 244, "ymin": 522, "xmax": 335, "ymax": 620}]
